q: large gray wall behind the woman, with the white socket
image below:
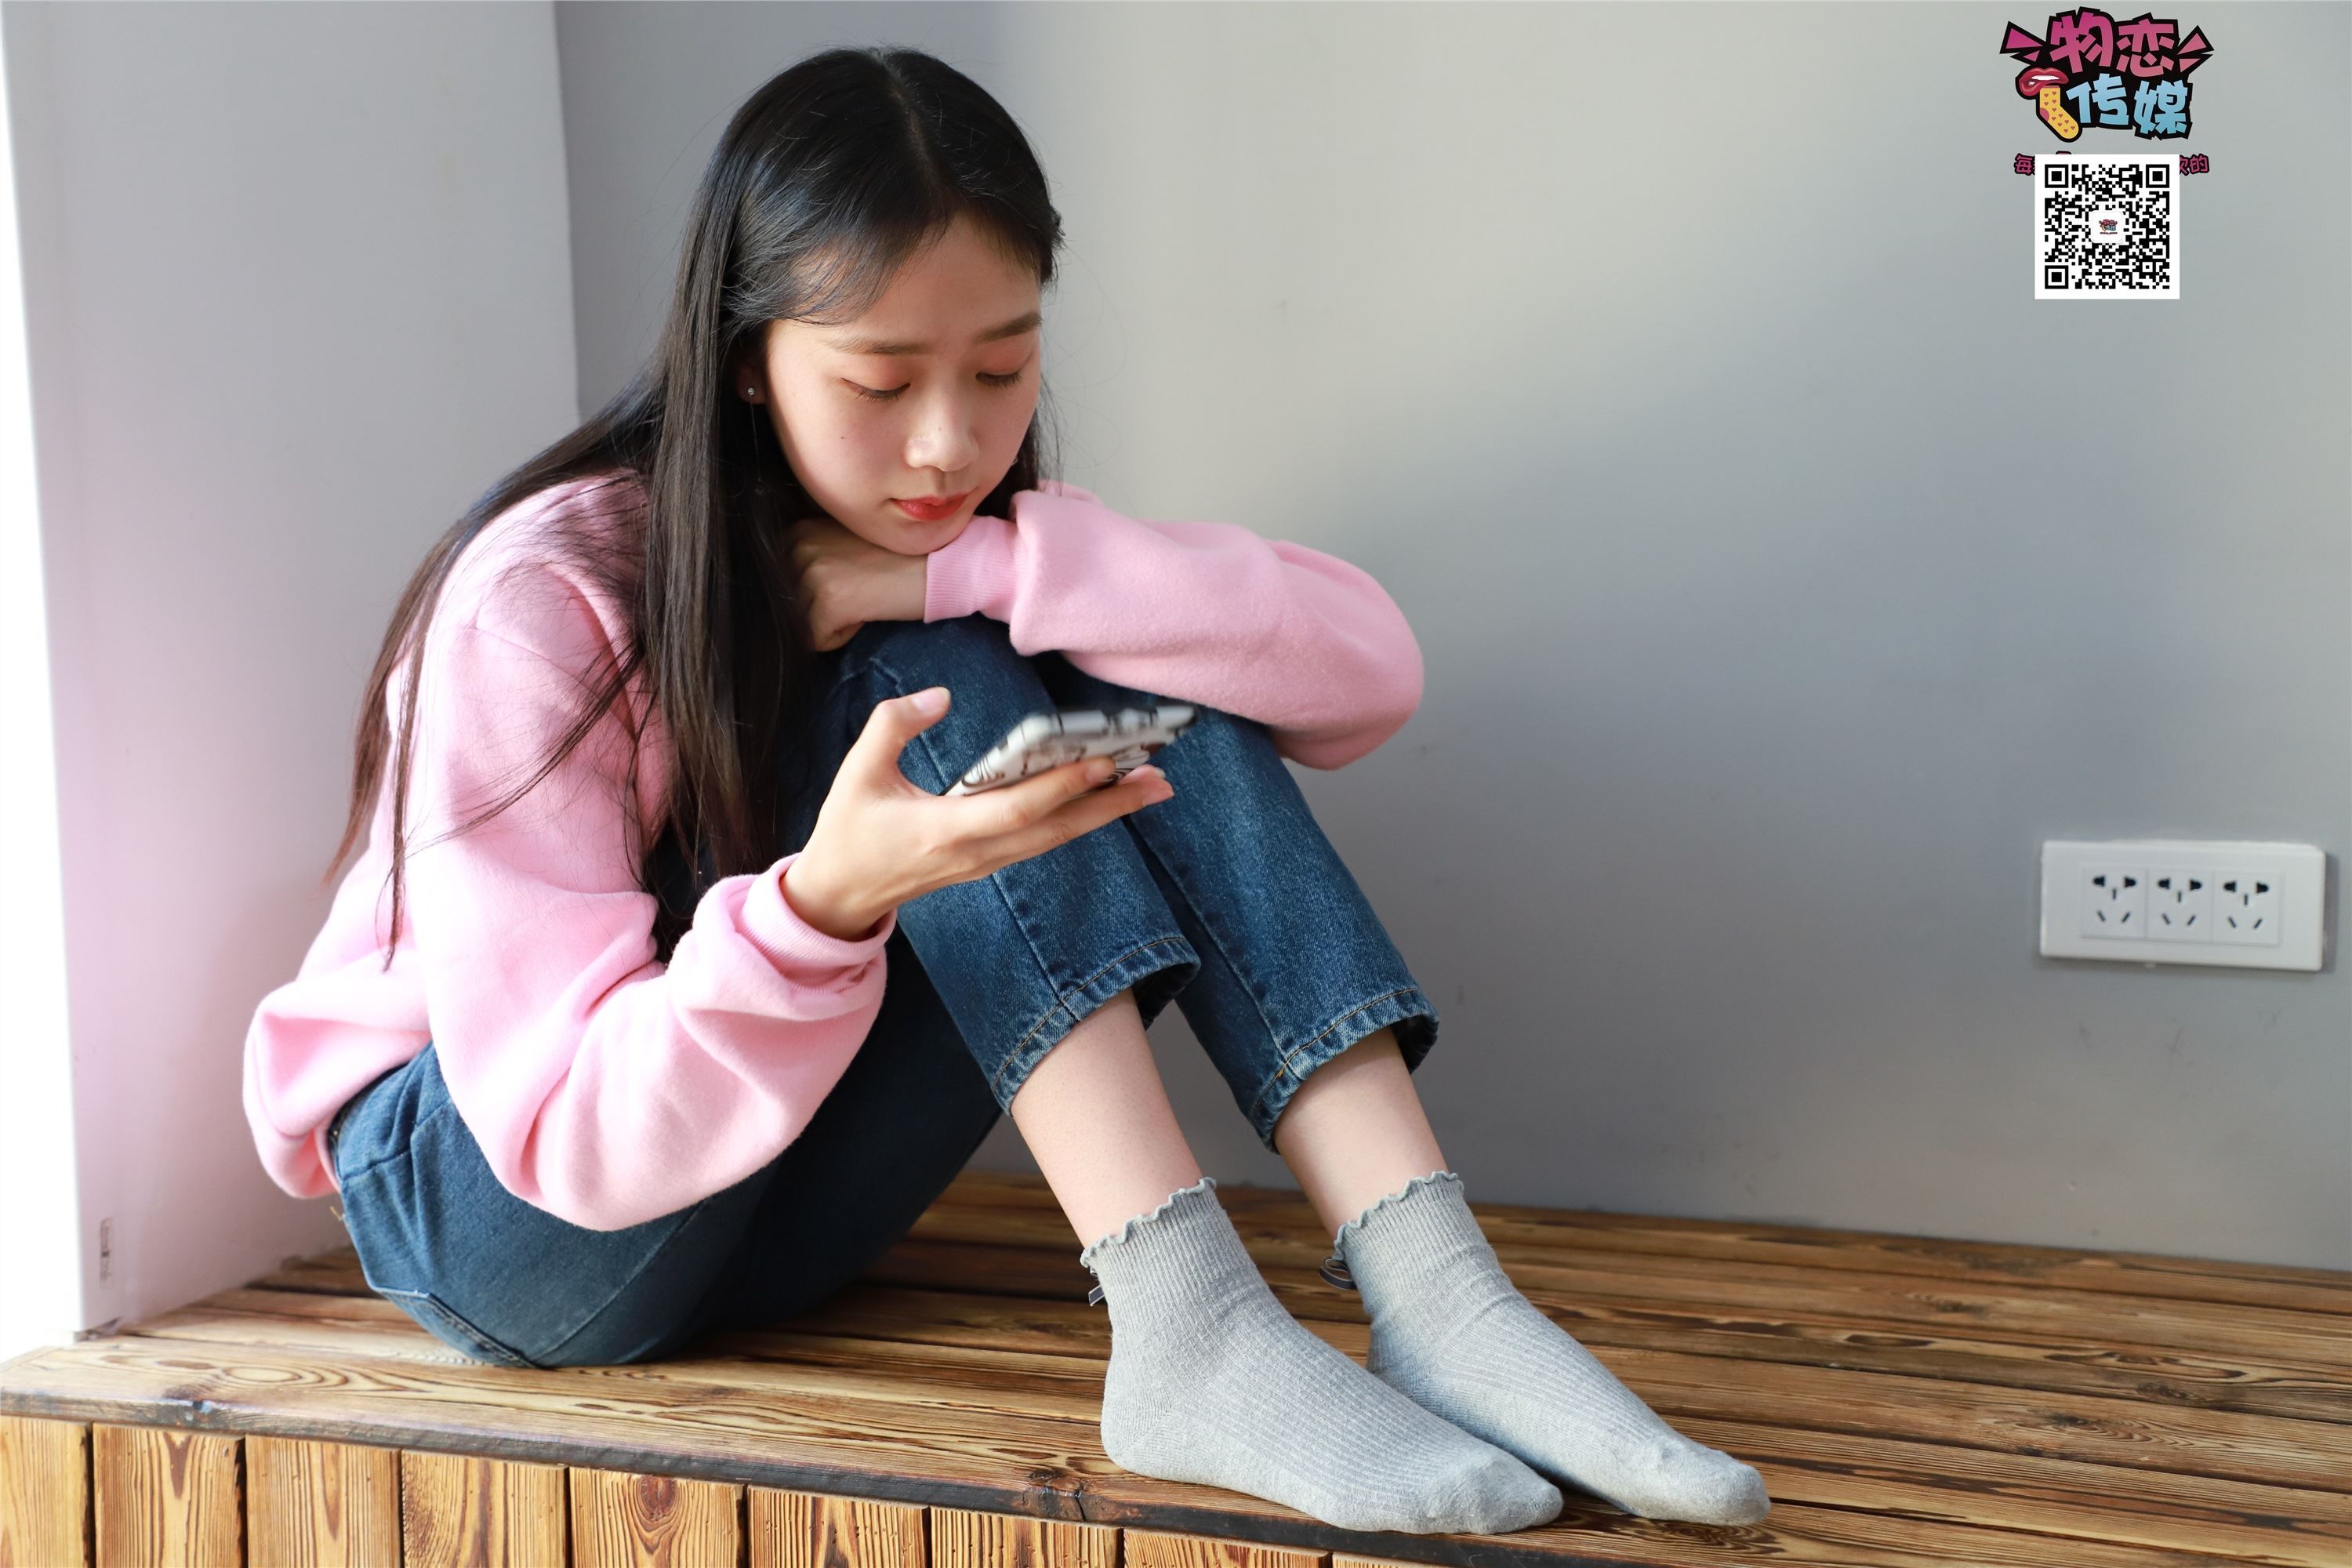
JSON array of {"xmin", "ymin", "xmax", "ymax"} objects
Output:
[{"xmin": 557, "ymin": 5, "xmax": 2352, "ymax": 1267}]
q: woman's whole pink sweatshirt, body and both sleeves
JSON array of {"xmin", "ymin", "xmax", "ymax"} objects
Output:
[{"xmin": 245, "ymin": 477, "xmax": 1421, "ymax": 1229}]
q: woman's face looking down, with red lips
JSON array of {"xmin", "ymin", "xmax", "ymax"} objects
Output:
[{"xmin": 757, "ymin": 216, "xmax": 1042, "ymax": 555}]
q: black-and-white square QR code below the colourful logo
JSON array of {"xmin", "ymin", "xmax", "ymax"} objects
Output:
[{"xmin": 2034, "ymin": 153, "xmax": 2180, "ymax": 299}]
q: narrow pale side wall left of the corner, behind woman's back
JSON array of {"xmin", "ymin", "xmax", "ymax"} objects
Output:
[{"xmin": 0, "ymin": 0, "xmax": 579, "ymax": 1354}]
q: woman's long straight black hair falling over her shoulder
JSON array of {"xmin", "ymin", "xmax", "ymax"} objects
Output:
[{"xmin": 325, "ymin": 47, "xmax": 1061, "ymax": 968}]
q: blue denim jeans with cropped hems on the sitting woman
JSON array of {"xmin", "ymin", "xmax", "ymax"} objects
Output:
[{"xmin": 329, "ymin": 614, "xmax": 1437, "ymax": 1366}]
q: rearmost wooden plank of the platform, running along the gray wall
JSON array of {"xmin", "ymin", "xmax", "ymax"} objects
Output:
[{"xmin": 913, "ymin": 1171, "xmax": 2352, "ymax": 1314}]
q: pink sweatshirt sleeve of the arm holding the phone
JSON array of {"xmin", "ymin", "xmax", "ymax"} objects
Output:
[{"xmin": 405, "ymin": 606, "xmax": 896, "ymax": 1229}]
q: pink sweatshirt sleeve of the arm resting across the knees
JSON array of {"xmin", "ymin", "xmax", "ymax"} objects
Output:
[{"xmin": 922, "ymin": 482, "xmax": 1421, "ymax": 769}]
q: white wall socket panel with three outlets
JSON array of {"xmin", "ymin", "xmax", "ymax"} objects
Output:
[{"xmin": 2042, "ymin": 839, "xmax": 2328, "ymax": 968}]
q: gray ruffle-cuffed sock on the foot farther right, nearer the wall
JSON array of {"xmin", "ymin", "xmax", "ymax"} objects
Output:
[{"xmin": 1338, "ymin": 1171, "xmax": 1771, "ymax": 1523}]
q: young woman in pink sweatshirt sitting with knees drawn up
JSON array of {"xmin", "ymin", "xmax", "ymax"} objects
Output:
[{"xmin": 245, "ymin": 49, "xmax": 1766, "ymax": 1533}]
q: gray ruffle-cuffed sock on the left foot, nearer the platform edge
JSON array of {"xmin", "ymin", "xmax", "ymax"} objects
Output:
[{"xmin": 1080, "ymin": 1175, "xmax": 1562, "ymax": 1535}]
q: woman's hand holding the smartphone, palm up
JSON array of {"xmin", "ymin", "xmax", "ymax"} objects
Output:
[{"xmin": 783, "ymin": 687, "xmax": 1176, "ymax": 940}]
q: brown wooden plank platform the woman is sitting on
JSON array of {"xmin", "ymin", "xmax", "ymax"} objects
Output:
[{"xmin": 0, "ymin": 1173, "xmax": 2352, "ymax": 1568}]
